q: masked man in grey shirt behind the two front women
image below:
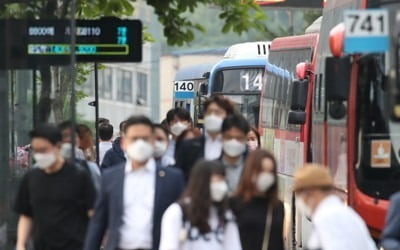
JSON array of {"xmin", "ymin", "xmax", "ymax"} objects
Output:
[{"xmin": 220, "ymin": 114, "xmax": 250, "ymax": 193}]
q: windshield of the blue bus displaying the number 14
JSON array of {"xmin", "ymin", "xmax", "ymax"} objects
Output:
[{"xmin": 211, "ymin": 67, "xmax": 264, "ymax": 94}]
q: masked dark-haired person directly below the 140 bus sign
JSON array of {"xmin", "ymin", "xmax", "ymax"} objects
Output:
[{"xmin": 166, "ymin": 108, "xmax": 192, "ymax": 158}]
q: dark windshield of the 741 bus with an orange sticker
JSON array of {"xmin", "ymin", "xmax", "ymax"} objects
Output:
[{"xmin": 356, "ymin": 54, "xmax": 400, "ymax": 199}]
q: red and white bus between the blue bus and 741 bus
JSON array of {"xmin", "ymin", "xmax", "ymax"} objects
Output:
[{"xmin": 259, "ymin": 31, "xmax": 318, "ymax": 248}]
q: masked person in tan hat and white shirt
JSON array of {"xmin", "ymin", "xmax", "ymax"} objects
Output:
[{"xmin": 293, "ymin": 164, "xmax": 376, "ymax": 250}]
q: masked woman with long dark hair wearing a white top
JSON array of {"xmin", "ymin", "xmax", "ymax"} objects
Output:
[{"xmin": 159, "ymin": 161, "xmax": 242, "ymax": 250}]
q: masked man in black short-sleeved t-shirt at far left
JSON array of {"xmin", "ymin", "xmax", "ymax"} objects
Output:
[{"xmin": 14, "ymin": 124, "xmax": 95, "ymax": 250}]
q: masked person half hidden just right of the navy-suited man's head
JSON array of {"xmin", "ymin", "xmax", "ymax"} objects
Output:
[{"xmin": 154, "ymin": 124, "xmax": 175, "ymax": 167}]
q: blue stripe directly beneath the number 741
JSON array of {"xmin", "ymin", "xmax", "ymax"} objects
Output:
[{"xmin": 344, "ymin": 36, "xmax": 389, "ymax": 53}]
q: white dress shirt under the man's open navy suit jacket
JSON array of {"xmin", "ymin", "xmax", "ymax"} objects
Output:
[{"xmin": 119, "ymin": 159, "xmax": 156, "ymax": 249}]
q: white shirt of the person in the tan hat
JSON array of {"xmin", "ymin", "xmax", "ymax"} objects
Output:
[{"xmin": 307, "ymin": 195, "xmax": 376, "ymax": 250}]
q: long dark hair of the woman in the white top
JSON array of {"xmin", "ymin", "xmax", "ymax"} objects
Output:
[{"xmin": 179, "ymin": 161, "xmax": 228, "ymax": 234}]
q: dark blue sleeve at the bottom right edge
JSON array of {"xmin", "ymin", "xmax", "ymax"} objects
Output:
[{"xmin": 381, "ymin": 193, "xmax": 400, "ymax": 250}]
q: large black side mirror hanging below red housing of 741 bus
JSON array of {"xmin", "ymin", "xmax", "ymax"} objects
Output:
[{"xmin": 325, "ymin": 56, "xmax": 351, "ymax": 102}]
